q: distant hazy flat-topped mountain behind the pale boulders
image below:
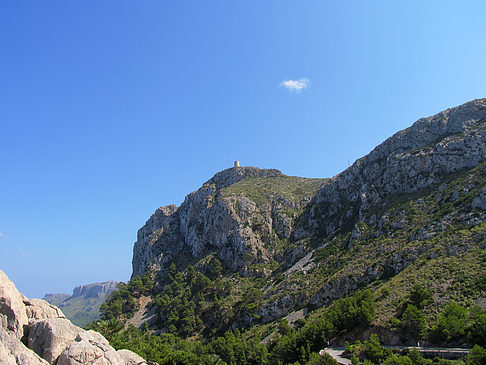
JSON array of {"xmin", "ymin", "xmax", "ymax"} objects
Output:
[{"xmin": 43, "ymin": 281, "xmax": 118, "ymax": 327}]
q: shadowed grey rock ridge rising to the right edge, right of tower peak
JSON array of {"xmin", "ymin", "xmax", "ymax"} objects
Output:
[{"xmin": 308, "ymin": 99, "xmax": 486, "ymax": 235}]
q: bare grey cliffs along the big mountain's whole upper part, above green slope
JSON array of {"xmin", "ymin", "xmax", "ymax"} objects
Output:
[{"xmin": 132, "ymin": 99, "xmax": 486, "ymax": 282}]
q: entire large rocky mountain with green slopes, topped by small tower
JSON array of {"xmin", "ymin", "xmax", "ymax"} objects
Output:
[{"xmin": 97, "ymin": 99, "xmax": 486, "ymax": 364}]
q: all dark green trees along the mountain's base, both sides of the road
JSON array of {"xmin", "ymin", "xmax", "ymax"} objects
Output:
[{"xmin": 90, "ymin": 274, "xmax": 486, "ymax": 365}]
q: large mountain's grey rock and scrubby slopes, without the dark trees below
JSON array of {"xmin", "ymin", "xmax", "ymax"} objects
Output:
[{"xmin": 125, "ymin": 99, "xmax": 486, "ymax": 336}]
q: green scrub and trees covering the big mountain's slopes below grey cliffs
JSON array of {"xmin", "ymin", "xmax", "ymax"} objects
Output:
[{"xmin": 94, "ymin": 163, "xmax": 486, "ymax": 364}]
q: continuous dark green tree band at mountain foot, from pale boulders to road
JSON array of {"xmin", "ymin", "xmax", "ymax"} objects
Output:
[{"xmin": 90, "ymin": 288, "xmax": 374, "ymax": 364}]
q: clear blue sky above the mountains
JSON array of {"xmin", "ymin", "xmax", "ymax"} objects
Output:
[{"xmin": 0, "ymin": 0, "xmax": 486, "ymax": 297}]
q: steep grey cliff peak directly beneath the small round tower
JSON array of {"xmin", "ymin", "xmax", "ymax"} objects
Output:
[{"xmin": 132, "ymin": 167, "xmax": 323, "ymax": 276}]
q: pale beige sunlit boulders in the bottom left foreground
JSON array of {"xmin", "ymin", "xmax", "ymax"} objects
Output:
[{"xmin": 0, "ymin": 270, "xmax": 148, "ymax": 365}]
